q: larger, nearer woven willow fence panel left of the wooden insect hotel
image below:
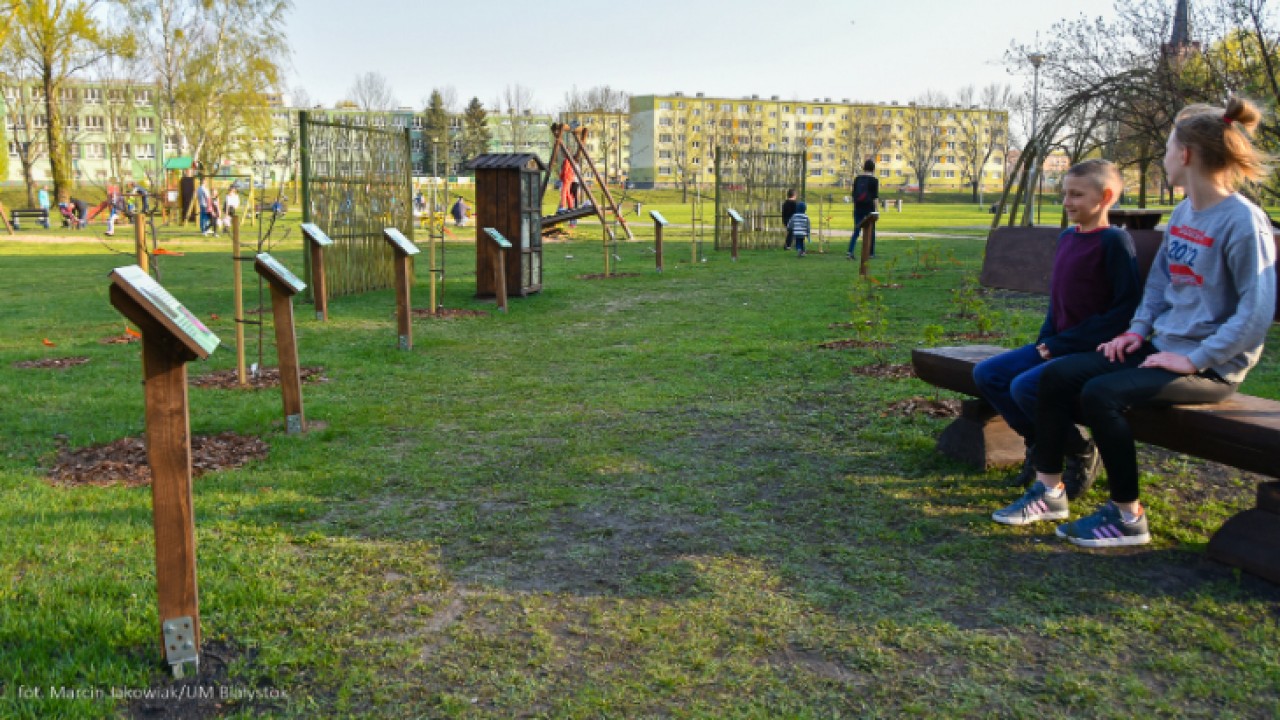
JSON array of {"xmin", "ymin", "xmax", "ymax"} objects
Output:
[{"xmin": 298, "ymin": 113, "xmax": 413, "ymax": 299}]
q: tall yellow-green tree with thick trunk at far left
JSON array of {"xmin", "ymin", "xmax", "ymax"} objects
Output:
[{"xmin": 10, "ymin": 0, "xmax": 132, "ymax": 202}]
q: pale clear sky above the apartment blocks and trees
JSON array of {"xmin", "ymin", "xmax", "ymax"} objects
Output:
[{"xmin": 288, "ymin": 0, "xmax": 1115, "ymax": 111}]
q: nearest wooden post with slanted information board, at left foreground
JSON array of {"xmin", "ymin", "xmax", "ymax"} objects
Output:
[{"xmin": 110, "ymin": 265, "xmax": 219, "ymax": 678}]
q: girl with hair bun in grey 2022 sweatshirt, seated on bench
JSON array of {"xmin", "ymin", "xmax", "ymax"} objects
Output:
[{"xmin": 997, "ymin": 97, "xmax": 1276, "ymax": 547}]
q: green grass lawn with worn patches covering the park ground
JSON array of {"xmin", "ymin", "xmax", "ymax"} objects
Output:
[{"xmin": 0, "ymin": 205, "xmax": 1280, "ymax": 717}]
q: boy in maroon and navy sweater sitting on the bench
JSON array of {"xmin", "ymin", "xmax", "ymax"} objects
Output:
[{"xmin": 973, "ymin": 160, "xmax": 1142, "ymax": 502}]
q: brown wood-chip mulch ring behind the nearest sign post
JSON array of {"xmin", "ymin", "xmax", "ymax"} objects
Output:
[{"xmin": 49, "ymin": 432, "xmax": 268, "ymax": 487}]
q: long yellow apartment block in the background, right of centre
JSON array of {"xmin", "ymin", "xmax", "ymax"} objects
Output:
[{"xmin": 631, "ymin": 92, "xmax": 1009, "ymax": 190}]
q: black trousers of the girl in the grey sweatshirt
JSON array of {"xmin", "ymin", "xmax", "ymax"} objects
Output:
[{"xmin": 1034, "ymin": 342, "xmax": 1235, "ymax": 502}]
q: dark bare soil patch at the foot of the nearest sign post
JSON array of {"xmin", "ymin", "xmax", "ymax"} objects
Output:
[{"xmin": 127, "ymin": 641, "xmax": 289, "ymax": 720}]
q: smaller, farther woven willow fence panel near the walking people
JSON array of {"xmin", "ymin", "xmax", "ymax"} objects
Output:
[{"xmin": 716, "ymin": 147, "xmax": 806, "ymax": 250}]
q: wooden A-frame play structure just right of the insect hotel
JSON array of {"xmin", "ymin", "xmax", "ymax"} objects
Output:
[{"xmin": 541, "ymin": 123, "xmax": 635, "ymax": 274}]
